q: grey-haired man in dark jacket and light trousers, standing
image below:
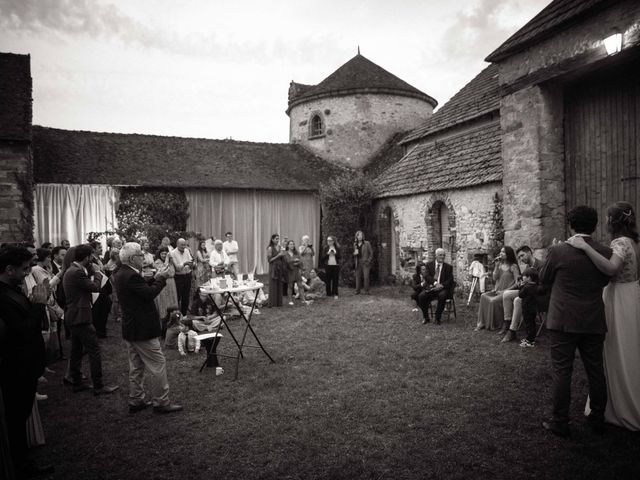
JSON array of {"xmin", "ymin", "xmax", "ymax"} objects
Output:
[{"xmin": 112, "ymin": 242, "xmax": 182, "ymax": 413}]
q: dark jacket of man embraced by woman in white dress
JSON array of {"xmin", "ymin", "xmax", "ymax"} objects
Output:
[{"xmin": 540, "ymin": 237, "xmax": 612, "ymax": 334}]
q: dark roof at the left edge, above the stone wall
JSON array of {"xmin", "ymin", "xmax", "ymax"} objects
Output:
[{"xmin": 0, "ymin": 53, "xmax": 32, "ymax": 141}]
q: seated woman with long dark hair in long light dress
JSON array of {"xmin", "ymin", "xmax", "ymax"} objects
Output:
[{"xmin": 475, "ymin": 247, "xmax": 520, "ymax": 332}]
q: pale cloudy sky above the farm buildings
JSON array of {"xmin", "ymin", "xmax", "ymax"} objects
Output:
[{"xmin": 0, "ymin": 0, "xmax": 550, "ymax": 143}]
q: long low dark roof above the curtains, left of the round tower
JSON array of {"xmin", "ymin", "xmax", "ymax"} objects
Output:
[{"xmin": 33, "ymin": 126, "xmax": 343, "ymax": 191}]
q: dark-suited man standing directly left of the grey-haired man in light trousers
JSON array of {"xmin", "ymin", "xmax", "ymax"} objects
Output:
[{"xmin": 62, "ymin": 244, "xmax": 118, "ymax": 395}]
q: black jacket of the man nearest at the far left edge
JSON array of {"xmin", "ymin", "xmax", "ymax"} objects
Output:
[{"xmin": 0, "ymin": 282, "xmax": 47, "ymax": 384}]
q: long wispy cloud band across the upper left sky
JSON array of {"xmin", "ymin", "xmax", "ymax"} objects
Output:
[{"xmin": 0, "ymin": 0, "xmax": 334, "ymax": 64}]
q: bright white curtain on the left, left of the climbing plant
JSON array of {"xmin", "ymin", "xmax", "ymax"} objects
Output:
[{"xmin": 35, "ymin": 184, "xmax": 118, "ymax": 245}]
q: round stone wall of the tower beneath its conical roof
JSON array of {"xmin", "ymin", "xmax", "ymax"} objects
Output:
[{"xmin": 289, "ymin": 94, "xmax": 433, "ymax": 168}]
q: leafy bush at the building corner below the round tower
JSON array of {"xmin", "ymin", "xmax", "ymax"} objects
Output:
[{"xmin": 320, "ymin": 172, "xmax": 378, "ymax": 286}]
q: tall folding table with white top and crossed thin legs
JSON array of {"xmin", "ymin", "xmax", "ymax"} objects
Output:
[{"xmin": 200, "ymin": 281, "xmax": 276, "ymax": 380}]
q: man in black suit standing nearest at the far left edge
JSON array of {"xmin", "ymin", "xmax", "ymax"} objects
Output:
[{"xmin": 0, "ymin": 247, "xmax": 53, "ymax": 478}]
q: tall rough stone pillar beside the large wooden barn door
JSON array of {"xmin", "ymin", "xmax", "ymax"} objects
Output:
[{"xmin": 500, "ymin": 86, "xmax": 565, "ymax": 255}]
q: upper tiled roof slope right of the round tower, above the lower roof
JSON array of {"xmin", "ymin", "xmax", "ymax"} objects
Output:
[{"xmin": 400, "ymin": 65, "xmax": 500, "ymax": 144}]
